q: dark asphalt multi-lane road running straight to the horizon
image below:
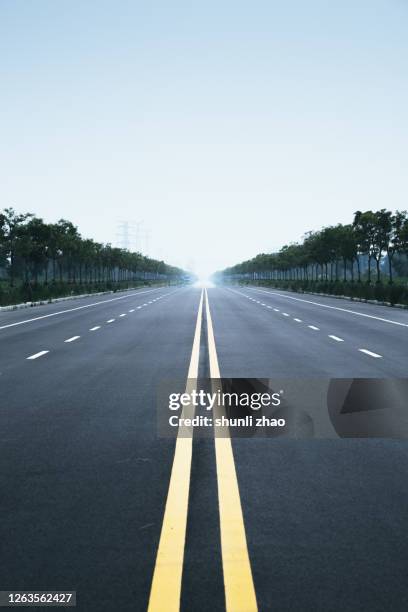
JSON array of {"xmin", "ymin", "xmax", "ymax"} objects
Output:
[{"xmin": 0, "ymin": 287, "xmax": 408, "ymax": 612}]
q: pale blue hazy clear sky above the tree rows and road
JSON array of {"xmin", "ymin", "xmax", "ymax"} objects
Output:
[{"xmin": 0, "ymin": 0, "xmax": 408, "ymax": 276}]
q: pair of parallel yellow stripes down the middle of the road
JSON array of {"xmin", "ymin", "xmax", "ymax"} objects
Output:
[{"xmin": 148, "ymin": 290, "xmax": 258, "ymax": 612}]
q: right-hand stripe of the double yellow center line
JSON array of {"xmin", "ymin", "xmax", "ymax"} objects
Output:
[{"xmin": 205, "ymin": 290, "xmax": 258, "ymax": 612}]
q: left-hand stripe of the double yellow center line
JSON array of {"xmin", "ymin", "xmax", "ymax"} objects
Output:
[{"xmin": 148, "ymin": 291, "xmax": 203, "ymax": 612}]
